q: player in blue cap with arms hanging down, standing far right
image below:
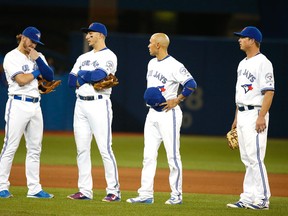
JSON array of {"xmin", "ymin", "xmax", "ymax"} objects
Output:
[{"xmin": 227, "ymin": 26, "xmax": 274, "ymax": 209}]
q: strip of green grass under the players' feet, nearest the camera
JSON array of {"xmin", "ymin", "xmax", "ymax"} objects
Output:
[{"xmin": 0, "ymin": 186, "xmax": 288, "ymax": 216}]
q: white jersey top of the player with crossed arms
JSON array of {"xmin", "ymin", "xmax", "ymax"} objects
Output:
[{"xmin": 71, "ymin": 48, "xmax": 117, "ymax": 96}]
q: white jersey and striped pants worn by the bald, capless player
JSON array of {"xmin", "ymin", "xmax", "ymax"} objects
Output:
[{"xmin": 138, "ymin": 56, "xmax": 193, "ymax": 200}]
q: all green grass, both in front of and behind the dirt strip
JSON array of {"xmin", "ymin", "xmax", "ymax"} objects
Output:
[{"xmin": 0, "ymin": 134, "xmax": 288, "ymax": 216}]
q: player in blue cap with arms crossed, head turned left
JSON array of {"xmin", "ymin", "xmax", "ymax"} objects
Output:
[{"xmin": 68, "ymin": 22, "xmax": 121, "ymax": 202}]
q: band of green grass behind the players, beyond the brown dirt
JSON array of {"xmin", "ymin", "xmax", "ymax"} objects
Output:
[{"xmin": 7, "ymin": 135, "xmax": 288, "ymax": 174}]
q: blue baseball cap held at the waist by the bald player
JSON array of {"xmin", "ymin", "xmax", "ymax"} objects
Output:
[{"xmin": 144, "ymin": 87, "xmax": 166, "ymax": 112}]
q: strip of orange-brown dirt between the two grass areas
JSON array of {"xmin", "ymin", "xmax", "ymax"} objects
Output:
[{"xmin": 10, "ymin": 164, "xmax": 288, "ymax": 197}]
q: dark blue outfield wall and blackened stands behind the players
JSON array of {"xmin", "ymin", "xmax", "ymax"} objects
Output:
[{"xmin": 0, "ymin": 0, "xmax": 288, "ymax": 137}]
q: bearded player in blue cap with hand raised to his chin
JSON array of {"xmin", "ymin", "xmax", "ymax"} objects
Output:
[{"xmin": 0, "ymin": 26, "xmax": 54, "ymax": 198}]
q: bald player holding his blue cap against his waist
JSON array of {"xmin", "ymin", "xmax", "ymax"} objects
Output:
[{"xmin": 127, "ymin": 33, "xmax": 197, "ymax": 205}]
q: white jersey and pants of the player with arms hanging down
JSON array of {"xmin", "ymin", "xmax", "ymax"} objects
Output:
[{"xmin": 235, "ymin": 53, "xmax": 274, "ymax": 205}]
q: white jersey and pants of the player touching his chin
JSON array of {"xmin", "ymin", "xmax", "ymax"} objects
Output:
[{"xmin": 0, "ymin": 48, "xmax": 47, "ymax": 195}]
